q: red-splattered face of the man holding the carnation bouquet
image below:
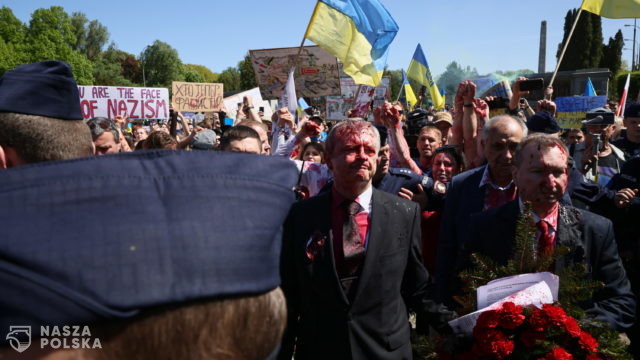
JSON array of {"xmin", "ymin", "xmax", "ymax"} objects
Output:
[{"xmin": 514, "ymin": 145, "xmax": 569, "ymax": 210}]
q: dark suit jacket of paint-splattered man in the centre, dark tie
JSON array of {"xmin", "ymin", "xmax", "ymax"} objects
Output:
[{"xmin": 279, "ymin": 189, "xmax": 451, "ymax": 360}]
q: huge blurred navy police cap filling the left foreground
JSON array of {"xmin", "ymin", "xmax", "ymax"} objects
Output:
[{"xmin": 0, "ymin": 150, "xmax": 297, "ymax": 346}]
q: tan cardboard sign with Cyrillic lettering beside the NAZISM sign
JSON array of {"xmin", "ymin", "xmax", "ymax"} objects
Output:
[{"xmin": 171, "ymin": 81, "xmax": 223, "ymax": 112}]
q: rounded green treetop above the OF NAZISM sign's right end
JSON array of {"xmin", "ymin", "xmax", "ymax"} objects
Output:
[{"xmin": 140, "ymin": 40, "xmax": 184, "ymax": 88}]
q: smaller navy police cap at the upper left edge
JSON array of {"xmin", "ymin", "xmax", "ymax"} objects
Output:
[{"xmin": 0, "ymin": 60, "xmax": 82, "ymax": 120}]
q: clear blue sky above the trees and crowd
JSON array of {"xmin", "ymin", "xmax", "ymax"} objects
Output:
[{"xmin": 3, "ymin": 0, "xmax": 640, "ymax": 76}]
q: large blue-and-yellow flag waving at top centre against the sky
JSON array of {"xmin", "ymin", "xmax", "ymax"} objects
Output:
[{"xmin": 304, "ymin": 0, "xmax": 398, "ymax": 86}]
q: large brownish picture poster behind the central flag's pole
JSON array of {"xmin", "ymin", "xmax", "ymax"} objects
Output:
[{"xmin": 249, "ymin": 46, "xmax": 340, "ymax": 99}]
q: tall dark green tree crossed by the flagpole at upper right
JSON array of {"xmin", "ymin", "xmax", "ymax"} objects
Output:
[{"xmin": 556, "ymin": 9, "xmax": 603, "ymax": 71}]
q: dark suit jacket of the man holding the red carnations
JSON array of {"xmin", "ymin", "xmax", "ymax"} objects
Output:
[{"xmin": 463, "ymin": 200, "xmax": 635, "ymax": 330}]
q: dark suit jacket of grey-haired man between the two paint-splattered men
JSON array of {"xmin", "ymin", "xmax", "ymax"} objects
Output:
[{"xmin": 436, "ymin": 165, "xmax": 487, "ymax": 304}]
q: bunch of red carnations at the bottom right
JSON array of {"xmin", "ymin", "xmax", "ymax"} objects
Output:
[{"xmin": 439, "ymin": 302, "xmax": 607, "ymax": 360}]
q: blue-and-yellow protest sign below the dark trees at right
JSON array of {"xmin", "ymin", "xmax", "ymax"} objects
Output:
[{"xmin": 554, "ymin": 96, "xmax": 607, "ymax": 129}]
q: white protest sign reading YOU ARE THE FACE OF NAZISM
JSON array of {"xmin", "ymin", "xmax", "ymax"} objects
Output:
[{"xmin": 78, "ymin": 86, "xmax": 169, "ymax": 119}]
